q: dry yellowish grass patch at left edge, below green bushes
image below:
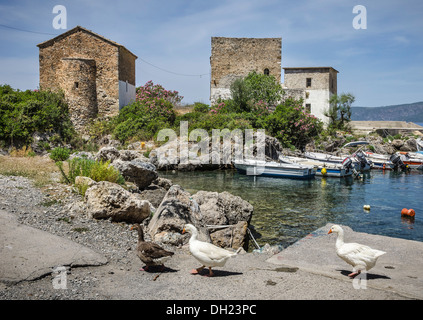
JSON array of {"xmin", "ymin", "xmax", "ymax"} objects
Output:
[{"xmin": 0, "ymin": 156, "xmax": 60, "ymax": 187}]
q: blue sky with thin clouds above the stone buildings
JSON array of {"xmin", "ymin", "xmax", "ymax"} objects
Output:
[{"xmin": 0, "ymin": 0, "xmax": 423, "ymax": 107}]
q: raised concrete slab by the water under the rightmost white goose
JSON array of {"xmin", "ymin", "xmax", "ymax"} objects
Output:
[{"xmin": 267, "ymin": 223, "xmax": 423, "ymax": 299}]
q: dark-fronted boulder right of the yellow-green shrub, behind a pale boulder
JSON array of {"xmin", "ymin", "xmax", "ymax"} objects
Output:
[{"xmin": 112, "ymin": 159, "xmax": 158, "ymax": 189}]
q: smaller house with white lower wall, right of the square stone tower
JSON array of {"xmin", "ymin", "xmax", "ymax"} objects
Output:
[{"xmin": 283, "ymin": 67, "xmax": 338, "ymax": 123}]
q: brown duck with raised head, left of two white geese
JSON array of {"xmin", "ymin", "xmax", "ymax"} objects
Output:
[{"xmin": 131, "ymin": 223, "xmax": 174, "ymax": 271}]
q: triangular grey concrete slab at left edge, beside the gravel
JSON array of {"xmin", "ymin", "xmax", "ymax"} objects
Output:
[{"xmin": 0, "ymin": 210, "xmax": 107, "ymax": 283}]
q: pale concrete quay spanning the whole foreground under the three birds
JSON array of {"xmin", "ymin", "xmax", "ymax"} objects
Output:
[{"xmin": 0, "ymin": 210, "xmax": 423, "ymax": 300}]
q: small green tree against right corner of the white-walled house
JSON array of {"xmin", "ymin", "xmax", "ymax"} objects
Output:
[{"xmin": 324, "ymin": 93, "xmax": 355, "ymax": 130}]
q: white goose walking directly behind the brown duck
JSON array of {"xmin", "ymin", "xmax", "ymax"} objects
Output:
[{"xmin": 182, "ymin": 224, "xmax": 241, "ymax": 277}]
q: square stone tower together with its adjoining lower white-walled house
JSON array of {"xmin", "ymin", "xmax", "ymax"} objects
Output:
[{"xmin": 210, "ymin": 37, "xmax": 338, "ymax": 123}]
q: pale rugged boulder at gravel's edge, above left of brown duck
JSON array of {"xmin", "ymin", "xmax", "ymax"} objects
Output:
[{"xmin": 85, "ymin": 181, "xmax": 151, "ymax": 223}]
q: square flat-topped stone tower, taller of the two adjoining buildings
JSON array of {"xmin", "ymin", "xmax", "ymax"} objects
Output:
[{"xmin": 210, "ymin": 37, "xmax": 282, "ymax": 104}]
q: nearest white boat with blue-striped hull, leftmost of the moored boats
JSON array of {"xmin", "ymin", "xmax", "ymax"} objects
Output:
[{"xmin": 234, "ymin": 159, "xmax": 316, "ymax": 179}]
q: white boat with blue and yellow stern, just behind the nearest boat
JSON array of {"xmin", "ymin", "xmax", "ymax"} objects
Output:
[{"xmin": 279, "ymin": 156, "xmax": 354, "ymax": 178}]
